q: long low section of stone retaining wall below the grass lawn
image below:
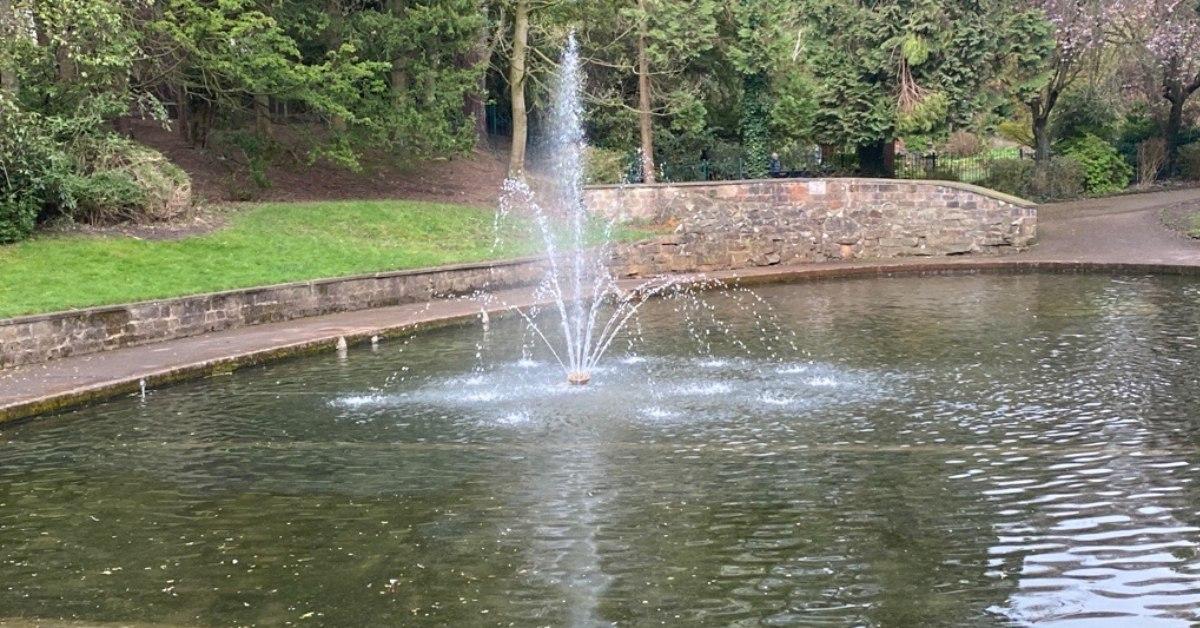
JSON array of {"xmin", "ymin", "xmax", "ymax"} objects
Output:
[{"xmin": 0, "ymin": 259, "xmax": 542, "ymax": 369}]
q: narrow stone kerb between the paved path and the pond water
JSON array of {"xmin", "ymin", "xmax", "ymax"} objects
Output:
[{"xmin": 0, "ymin": 259, "xmax": 1200, "ymax": 425}]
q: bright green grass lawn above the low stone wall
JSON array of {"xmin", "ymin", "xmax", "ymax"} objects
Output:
[{"xmin": 0, "ymin": 201, "xmax": 643, "ymax": 318}]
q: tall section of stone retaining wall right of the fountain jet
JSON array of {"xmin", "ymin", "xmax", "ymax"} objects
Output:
[{"xmin": 587, "ymin": 179, "xmax": 1037, "ymax": 276}]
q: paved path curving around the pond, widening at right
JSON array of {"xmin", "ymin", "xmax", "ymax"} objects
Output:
[{"xmin": 0, "ymin": 189, "xmax": 1200, "ymax": 423}]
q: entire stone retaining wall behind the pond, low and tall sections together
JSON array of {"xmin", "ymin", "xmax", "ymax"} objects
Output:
[{"xmin": 0, "ymin": 179, "xmax": 1037, "ymax": 369}]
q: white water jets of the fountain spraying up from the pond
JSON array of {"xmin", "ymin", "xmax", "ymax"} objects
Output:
[{"xmin": 496, "ymin": 34, "xmax": 679, "ymax": 385}]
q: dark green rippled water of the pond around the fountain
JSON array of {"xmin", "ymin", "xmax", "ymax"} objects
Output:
[{"xmin": 0, "ymin": 275, "xmax": 1200, "ymax": 626}]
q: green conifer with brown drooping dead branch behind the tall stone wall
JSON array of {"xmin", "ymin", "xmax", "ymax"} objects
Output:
[{"xmin": 804, "ymin": 0, "xmax": 1006, "ymax": 173}]
